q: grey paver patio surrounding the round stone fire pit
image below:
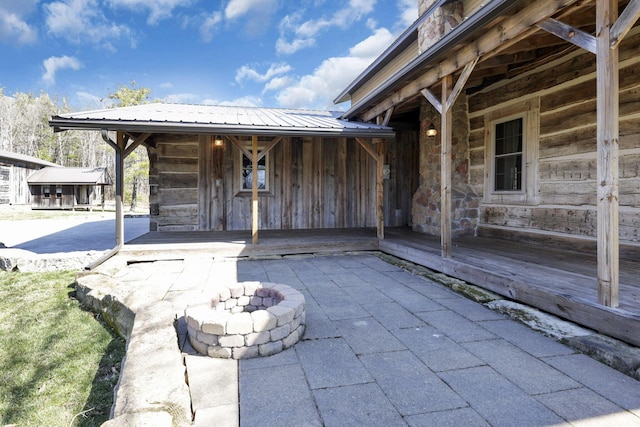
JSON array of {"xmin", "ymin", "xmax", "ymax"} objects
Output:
[{"xmin": 100, "ymin": 254, "xmax": 640, "ymax": 427}]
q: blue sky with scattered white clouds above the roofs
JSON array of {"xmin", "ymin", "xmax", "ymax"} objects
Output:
[{"xmin": 0, "ymin": 0, "xmax": 418, "ymax": 111}]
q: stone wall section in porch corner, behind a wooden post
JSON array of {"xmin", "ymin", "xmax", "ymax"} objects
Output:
[{"xmin": 412, "ymin": 94, "xmax": 480, "ymax": 236}]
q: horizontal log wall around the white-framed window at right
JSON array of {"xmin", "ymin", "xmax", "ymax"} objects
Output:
[{"xmin": 468, "ymin": 28, "xmax": 640, "ymax": 243}]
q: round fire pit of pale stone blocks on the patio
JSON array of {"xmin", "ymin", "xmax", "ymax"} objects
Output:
[{"xmin": 185, "ymin": 282, "xmax": 305, "ymax": 359}]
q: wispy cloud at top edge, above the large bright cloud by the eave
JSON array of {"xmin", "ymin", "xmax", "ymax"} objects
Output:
[{"xmin": 276, "ymin": 0, "xmax": 376, "ymax": 54}]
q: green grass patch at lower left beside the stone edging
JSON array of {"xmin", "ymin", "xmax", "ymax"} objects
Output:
[{"xmin": 0, "ymin": 271, "xmax": 125, "ymax": 426}]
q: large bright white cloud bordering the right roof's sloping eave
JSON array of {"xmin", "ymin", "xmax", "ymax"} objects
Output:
[{"xmin": 276, "ymin": 28, "xmax": 394, "ymax": 109}]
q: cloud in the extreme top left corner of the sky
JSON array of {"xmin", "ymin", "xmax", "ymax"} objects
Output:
[{"xmin": 0, "ymin": 0, "xmax": 38, "ymax": 45}]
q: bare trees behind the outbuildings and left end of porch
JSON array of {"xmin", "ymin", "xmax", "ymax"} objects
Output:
[{"xmin": 0, "ymin": 82, "xmax": 151, "ymax": 210}]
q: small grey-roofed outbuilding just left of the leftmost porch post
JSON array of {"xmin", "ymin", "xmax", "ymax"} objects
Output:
[{"xmin": 28, "ymin": 167, "xmax": 111, "ymax": 210}]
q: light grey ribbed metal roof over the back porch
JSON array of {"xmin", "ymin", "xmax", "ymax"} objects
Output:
[{"xmin": 49, "ymin": 103, "xmax": 395, "ymax": 138}]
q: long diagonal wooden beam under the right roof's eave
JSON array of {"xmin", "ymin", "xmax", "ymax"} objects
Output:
[{"xmin": 362, "ymin": 0, "xmax": 577, "ymax": 121}]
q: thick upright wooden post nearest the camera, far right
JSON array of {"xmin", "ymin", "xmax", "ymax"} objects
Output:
[{"xmin": 596, "ymin": 0, "xmax": 619, "ymax": 307}]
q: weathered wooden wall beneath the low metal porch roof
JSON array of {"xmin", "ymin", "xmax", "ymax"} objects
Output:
[{"xmin": 150, "ymin": 133, "xmax": 418, "ymax": 231}]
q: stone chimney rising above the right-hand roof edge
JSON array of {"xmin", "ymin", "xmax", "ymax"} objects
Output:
[{"xmin": 418, "ymin": 0, "xmax": 464, "ymax": 53}]
